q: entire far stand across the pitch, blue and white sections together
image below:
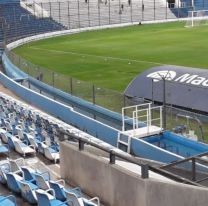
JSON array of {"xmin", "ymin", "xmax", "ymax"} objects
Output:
[{"xmin": 0, "ymin": 0, "xmax": 187, "ymax": 45}]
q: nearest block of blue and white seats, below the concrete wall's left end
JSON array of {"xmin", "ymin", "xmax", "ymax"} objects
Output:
[{"xmin": 0, "ymin": 158, "xmax": 100, "ymax": 206}]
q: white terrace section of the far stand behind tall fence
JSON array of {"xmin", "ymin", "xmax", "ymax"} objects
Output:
[{"xmin": 31, "ymin": 0, "xmax": 176, "ymax": 29}]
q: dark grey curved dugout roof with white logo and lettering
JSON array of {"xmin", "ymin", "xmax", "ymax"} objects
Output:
[{"xmin": 125, "ymin": 65, "xmax": 208, "ymax": 112}]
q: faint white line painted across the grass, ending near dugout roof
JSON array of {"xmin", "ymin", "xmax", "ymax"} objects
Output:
[{"xmin": 30, "ymin": 47, "xmax": 164, "ymax": 65}]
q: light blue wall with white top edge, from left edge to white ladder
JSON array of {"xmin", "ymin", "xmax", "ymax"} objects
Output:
[{"xmin": 0, "ymin": 59, "xmax": 121, "ymax": 146}]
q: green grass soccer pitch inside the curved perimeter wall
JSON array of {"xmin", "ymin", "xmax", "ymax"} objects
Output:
[{"xmin": 14, "ymin": 22, "xmax": 208, "ymax": 91}]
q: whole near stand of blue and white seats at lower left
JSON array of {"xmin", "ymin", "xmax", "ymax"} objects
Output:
[{"xmin": 0, "ymin": 93, "xmax": 104, "ymax": 206}]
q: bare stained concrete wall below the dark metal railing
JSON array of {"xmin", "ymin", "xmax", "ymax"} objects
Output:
[{"xmin": 60, "ymin": 142, "xmax": 208, "ymax": 206}]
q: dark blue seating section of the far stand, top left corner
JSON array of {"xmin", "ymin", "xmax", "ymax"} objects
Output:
[{"xmin": 0, "ymin": 0, "xmax": 65, "ymax": 41}]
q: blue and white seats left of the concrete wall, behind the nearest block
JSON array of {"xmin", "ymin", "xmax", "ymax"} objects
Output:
[{"xmin": 0, "ymin": 95, "xmax": 59, "ymax": 162}]
